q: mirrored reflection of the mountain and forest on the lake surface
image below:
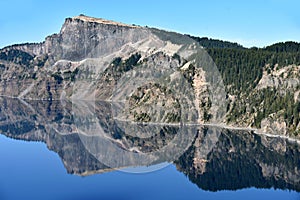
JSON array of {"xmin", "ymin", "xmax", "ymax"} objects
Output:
[{"xmin": 0, "ymin": 98, "xmax": 300, "ymax": 191}]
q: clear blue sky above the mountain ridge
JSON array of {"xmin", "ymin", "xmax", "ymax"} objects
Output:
[{"xmin": 0, "ymin": 0, "xmax": 300, "ymax": 48}]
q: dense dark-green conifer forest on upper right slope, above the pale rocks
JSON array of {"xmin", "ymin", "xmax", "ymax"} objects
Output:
[{"xmin": 190, "ymin": 36, "xmax": 300, "ymax": 94}]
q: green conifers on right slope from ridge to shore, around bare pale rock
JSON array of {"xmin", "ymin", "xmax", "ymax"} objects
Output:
[{"xmin": 189, "ymin": 36, "xmax": 300, "ymax": 135}]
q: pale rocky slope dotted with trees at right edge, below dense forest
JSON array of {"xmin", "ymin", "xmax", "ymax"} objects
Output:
[{"xmin": 228, "ymin": 64, "xmax": 300, "ymax": 138}]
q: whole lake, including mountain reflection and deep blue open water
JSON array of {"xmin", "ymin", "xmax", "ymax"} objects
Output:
[{"xmin": 0, "ymin": 98, "xmax": 300, "ymax": 200}]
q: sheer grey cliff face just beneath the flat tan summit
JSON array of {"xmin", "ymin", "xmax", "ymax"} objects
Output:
[{"xmin": 45, "ymin": 16, "xmax": 149, "ymax": 61}]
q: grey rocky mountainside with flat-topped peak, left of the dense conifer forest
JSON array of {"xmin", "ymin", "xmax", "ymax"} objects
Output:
[{"xmin": 0, "ymin": 16, "xmax": 226, "ymax": 123}]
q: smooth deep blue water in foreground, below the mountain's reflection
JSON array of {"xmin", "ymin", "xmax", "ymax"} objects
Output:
[{"xmin": 0, "ymin": 135, "xmax": 300, "ymax": 200}]
